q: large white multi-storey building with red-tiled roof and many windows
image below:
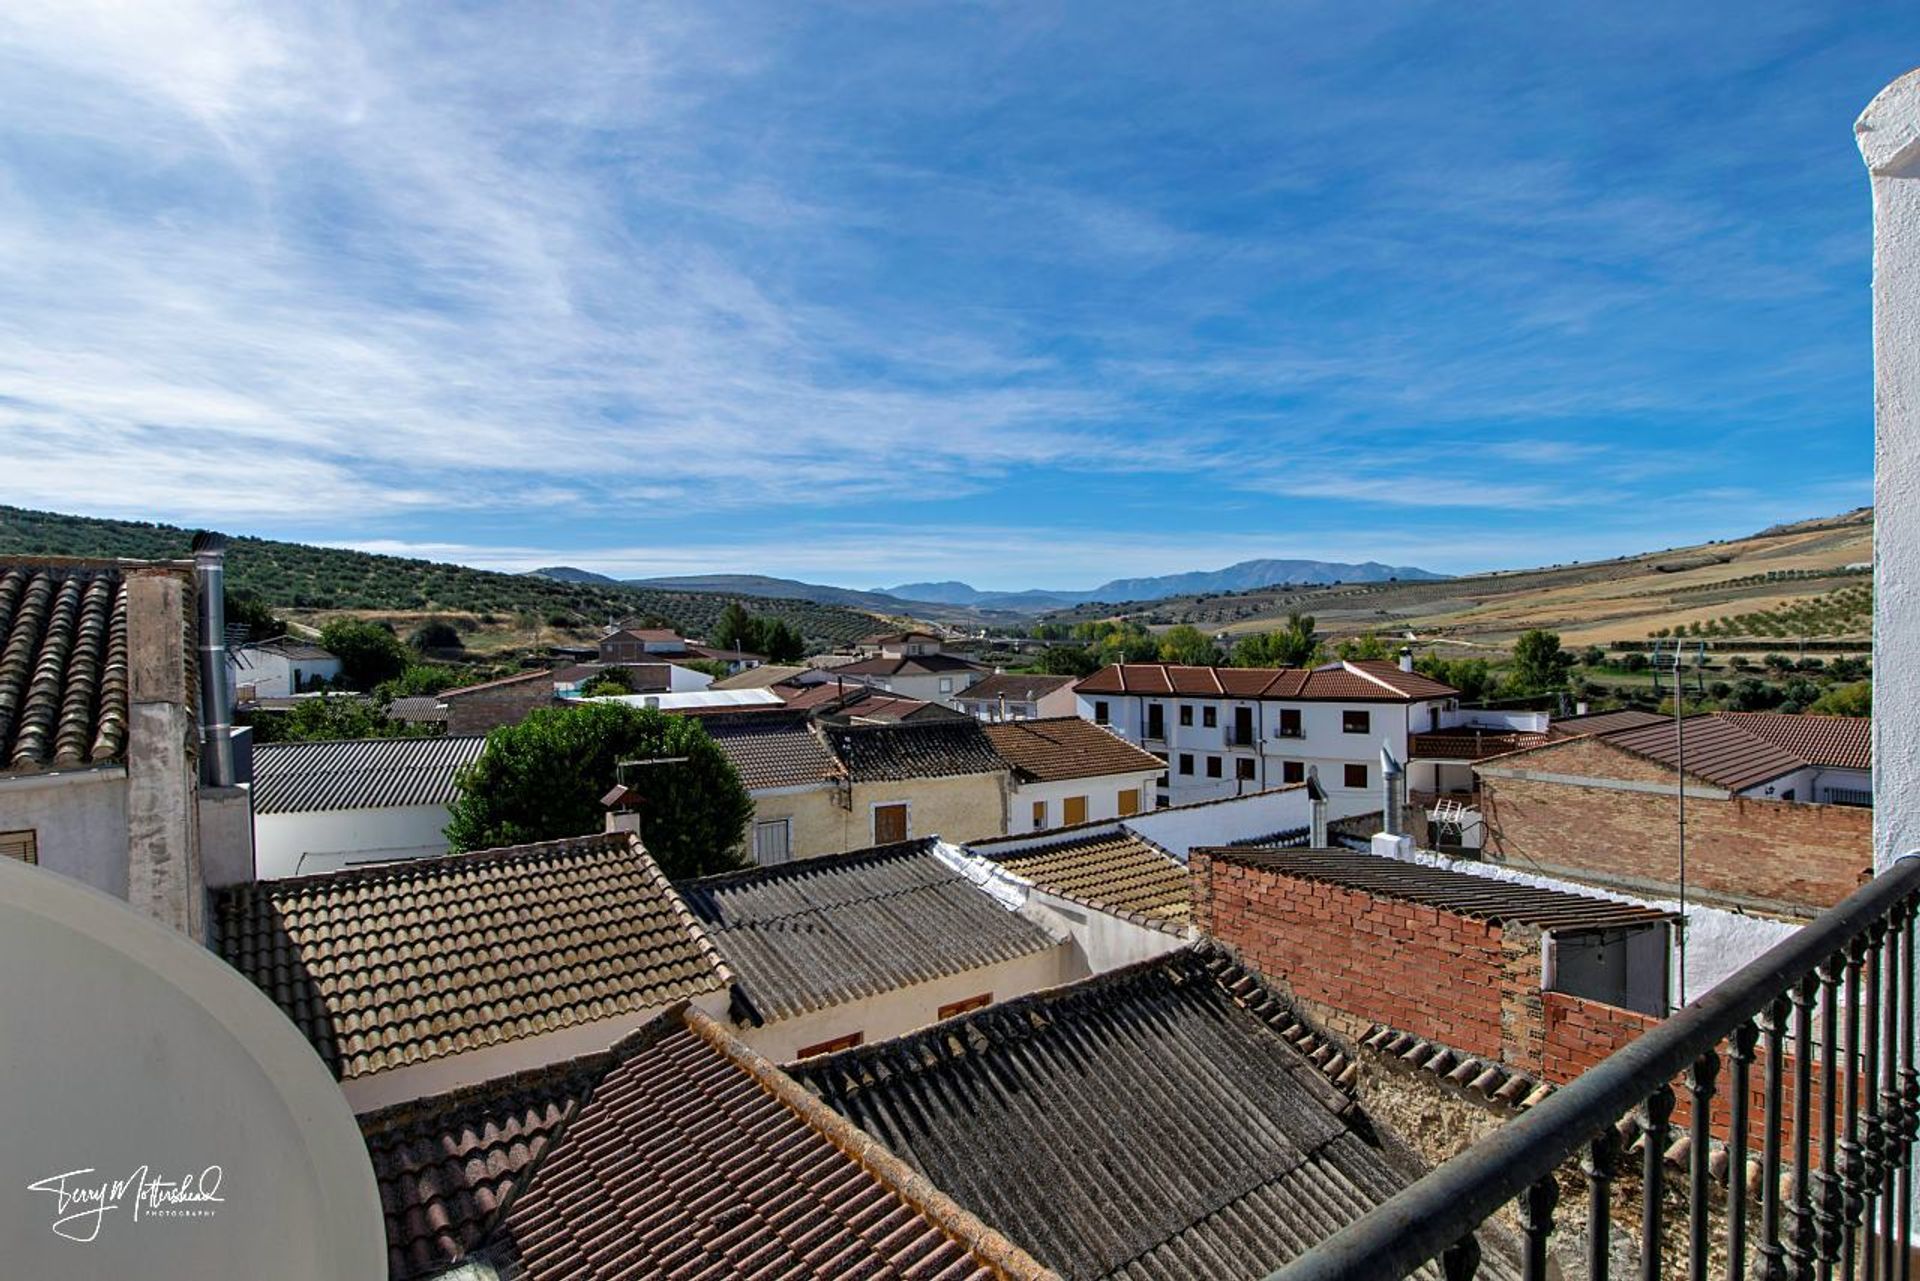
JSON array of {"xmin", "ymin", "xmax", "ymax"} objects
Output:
[{"xmin": 1073, "ymin": 661, "xmax": 1459, "ymax": 818}]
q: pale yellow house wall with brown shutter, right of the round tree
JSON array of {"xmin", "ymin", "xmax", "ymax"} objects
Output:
[{"xmin": 747, "ymin": 774, "xmax": 1013, "ymax": 858}]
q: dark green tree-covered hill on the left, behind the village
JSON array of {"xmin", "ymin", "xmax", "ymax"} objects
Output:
[{"xmin": 0, "ymin": 507, "xmax": 876, "ymax": 643}]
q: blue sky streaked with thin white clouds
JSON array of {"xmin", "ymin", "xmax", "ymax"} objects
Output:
[{"xmin": 0, "ymin": 0, "xmax": 1920, "ymax": 588}]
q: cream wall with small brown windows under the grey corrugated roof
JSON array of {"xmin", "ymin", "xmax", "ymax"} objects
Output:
[{"xmin": 733, "ymin": 941, "xmax": 1089, "ymax": 1062}]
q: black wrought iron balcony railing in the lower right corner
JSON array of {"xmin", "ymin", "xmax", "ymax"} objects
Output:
[{"xmin": 1273, "ymin": 858, "xmax": 1920, "ymax": 1281}]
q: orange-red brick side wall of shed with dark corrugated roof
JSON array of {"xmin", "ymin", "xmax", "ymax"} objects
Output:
[{"xmin": 1190, "ymin": 851, "xmax": 1544, "ymax": 1072}]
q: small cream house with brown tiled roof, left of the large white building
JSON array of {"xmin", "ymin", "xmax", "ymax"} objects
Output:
[{"xmin": 985, "ymin": 716, "xmax": 1167, "ymax": 834}]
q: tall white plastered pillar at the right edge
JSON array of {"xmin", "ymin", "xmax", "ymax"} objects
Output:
[{"xmin": 1853, "ymin": 71, "xmax": 1920, "ymax": 870}]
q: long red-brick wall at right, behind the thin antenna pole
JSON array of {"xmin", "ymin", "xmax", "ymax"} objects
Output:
[{"xmin": 1480, "ymin": 741, "xmax": 1874, "ymax": 908}]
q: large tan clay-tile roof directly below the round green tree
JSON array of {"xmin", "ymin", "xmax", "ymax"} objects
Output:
[{"xmin": 215, "ymin": 834, "xmax": 730, "ymax": 1079}]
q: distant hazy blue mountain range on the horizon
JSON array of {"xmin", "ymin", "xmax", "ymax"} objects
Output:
[{"xmin": 532, "ymin": 561, "xmax": 1446, "ymax": 618}]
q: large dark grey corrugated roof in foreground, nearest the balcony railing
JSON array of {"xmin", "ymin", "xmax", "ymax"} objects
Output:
[{"xmin": 787, "ymin": 949, "xmax": 1513, "ymax": 1281}]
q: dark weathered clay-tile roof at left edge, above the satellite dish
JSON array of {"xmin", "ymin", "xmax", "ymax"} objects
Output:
[{"xmin": 0, "ymin": 565, "xmax": 130, "ymax": 774}]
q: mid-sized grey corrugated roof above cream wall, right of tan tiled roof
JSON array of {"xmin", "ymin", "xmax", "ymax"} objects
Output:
[{"xmin": 678, "ymin": 837, "xmax": 1062, "ymax": 1022}]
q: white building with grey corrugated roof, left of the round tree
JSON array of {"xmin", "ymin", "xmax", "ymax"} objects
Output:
[{"xmin": 253, "ymin": 734, "xmax": 486, "ymax": 880}]
